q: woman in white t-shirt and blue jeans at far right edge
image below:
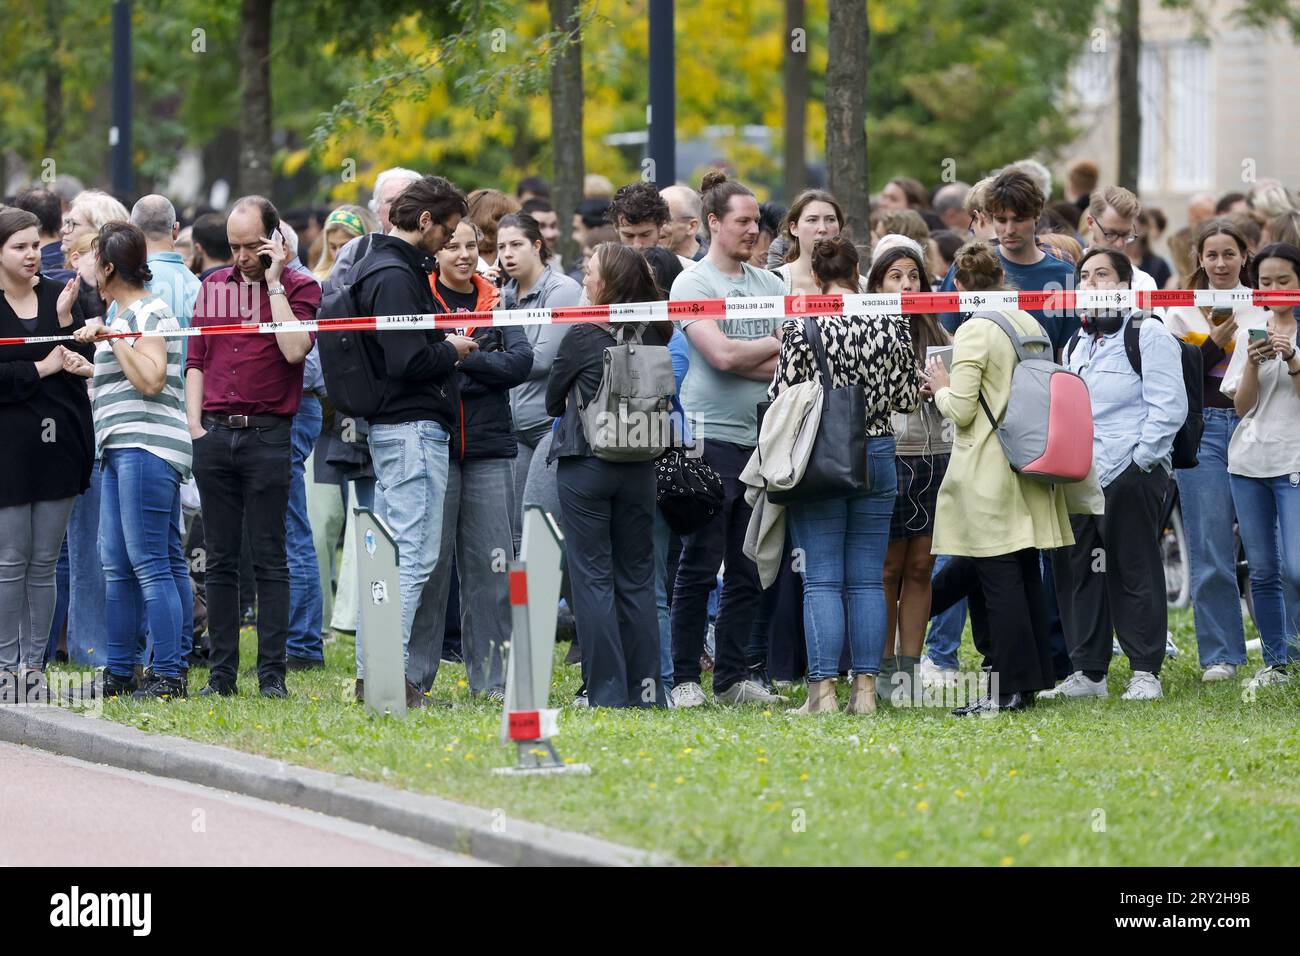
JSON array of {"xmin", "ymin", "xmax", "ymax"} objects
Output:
[{"xmin": 1223, "ymin": 242, "xmax": 1300, "ymax": 689}]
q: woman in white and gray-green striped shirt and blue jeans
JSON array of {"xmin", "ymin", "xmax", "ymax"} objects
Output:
[{"xmin": 69, "ymin": 222, "xmax": 191, "ymax": 700}]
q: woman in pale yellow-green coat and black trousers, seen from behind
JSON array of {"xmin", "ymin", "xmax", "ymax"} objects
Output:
[{"xmin": 927, "ymin": 242, "xmax": 1074, "ymax": 715}]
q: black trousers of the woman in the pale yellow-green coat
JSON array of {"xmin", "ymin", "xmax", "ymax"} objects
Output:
[{"xmin": 930, "ymin": 549, "xmax": 1056, "ymax": 695}]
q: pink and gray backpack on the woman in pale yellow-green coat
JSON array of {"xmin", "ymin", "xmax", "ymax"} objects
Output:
[{"xmin": 971, "ymin": 312, "xmax": 1092, "ymax": 485}]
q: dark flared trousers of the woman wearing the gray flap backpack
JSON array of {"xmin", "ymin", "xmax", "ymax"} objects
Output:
[{"xmin": 556, "ymin": 458, "xmax": 667, "ymax": 708}]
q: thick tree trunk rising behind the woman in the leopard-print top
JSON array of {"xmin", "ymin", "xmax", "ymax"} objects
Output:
[{"xmin": 826, "ymin": 0, "xmax": 870, "ymax": 246}]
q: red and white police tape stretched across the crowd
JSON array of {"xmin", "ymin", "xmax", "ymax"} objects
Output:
[{"xmin": 0, "ymin": 289, "xmax": 1300, "ymax": 346}]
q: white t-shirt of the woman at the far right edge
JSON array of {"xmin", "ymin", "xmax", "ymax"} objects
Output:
[{"xmin": 1222, "ymin": 329, "xmax": 1300, "ymax": 479}]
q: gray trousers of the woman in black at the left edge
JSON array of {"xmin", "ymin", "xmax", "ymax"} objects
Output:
[{"xmin": 0, "ymin": 498, "xmax": 77, "ymax": 671}]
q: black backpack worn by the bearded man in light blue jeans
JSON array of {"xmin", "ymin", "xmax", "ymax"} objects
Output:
[{"xmin": 316, "ymin": 251, "xmax": 400, "ymax": 419}]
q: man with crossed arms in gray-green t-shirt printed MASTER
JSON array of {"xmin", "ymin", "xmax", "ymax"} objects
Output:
[{"xmin": 670, "ymin": 177, "xmax": 785, "ymax": 708}]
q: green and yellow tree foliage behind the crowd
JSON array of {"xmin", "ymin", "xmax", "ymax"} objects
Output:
[{"xmin": 10, "ymin": 0, "xmax": 1300, "ymax": 202}]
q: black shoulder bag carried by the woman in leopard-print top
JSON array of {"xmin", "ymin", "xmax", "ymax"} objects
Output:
[{"xmin": 767, "ymin": 317, "xmax": 871, "ymax": 505}]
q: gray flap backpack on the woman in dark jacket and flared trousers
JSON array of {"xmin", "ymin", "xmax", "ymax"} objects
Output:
[{"xmin": 573, "ymin": 323, "xmax": 677, "ymax": 462}]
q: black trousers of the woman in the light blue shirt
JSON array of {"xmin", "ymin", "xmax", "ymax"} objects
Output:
[{"xmin": 1052, "ymin": 464, "xmax": 1169, "ymax": 675}]
